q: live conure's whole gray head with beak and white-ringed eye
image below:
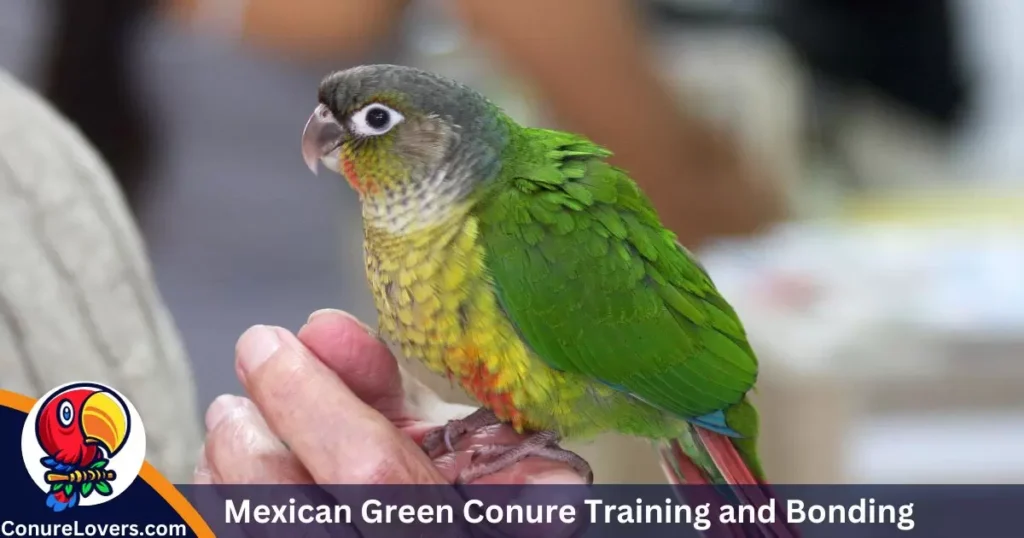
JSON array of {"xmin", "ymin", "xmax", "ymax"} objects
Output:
[{"xmin": 302, "ymin": 66, "xmax": 510, "ymax": 224}]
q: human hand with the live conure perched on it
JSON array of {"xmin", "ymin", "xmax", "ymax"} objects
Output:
[{"xmin": 195, "ymin": 311, "xmax": 584, "ymax": 484}]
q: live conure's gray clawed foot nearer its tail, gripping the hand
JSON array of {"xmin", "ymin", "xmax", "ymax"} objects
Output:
[{"xmin": 456, "ymin": 431, "xmax": 594, "ymax": 485}]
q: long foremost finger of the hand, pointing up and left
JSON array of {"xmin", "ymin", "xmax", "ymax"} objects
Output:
[{"xmin": 236, "ymin": 326, "xmax": 442, "ymax": 484}]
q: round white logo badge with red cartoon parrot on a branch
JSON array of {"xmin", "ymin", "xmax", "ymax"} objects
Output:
[{"xmin": 22, "ymin": 382, "xmax": 145, "ymax": 512}]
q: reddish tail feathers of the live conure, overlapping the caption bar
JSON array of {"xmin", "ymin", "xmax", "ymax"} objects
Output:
[{"xmin": 660, "ymin": 425, "xmax": 800, "ymax": 538}]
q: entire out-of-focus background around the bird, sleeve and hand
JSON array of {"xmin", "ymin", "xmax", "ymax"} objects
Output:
[{"xmin": 0, "ymin": 0, "xmax": 1024, "ymax": 483}]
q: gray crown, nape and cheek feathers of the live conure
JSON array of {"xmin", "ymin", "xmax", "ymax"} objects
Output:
[{"xmin": 318, "ymin": 65, "xmax": 512, "ymax": 231}]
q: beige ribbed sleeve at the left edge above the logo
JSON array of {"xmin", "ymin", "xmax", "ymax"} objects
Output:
[{"xmin": 0, "ymin": 71, "xmax": 201, "ymax": 482}]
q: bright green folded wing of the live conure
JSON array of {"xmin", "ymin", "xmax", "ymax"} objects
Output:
[{"xmin": 478, "ymin": 129, "xmax": 758, "ymax": 428}]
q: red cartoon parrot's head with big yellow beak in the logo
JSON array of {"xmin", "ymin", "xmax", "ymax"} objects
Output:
[{"xmin": 36, "ymin": 384, "xmax": 130, "ymax": 465}]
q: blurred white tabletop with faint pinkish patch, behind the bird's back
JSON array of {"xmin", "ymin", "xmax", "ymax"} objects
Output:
[{"xmin": 701, "ymin": 222, "xmax": 1024, "ymax": 376}]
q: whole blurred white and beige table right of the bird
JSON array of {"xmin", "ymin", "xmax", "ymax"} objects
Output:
[{"xmin": 702, "ymin": 188, "xmax": 1024, "ymax": 483}]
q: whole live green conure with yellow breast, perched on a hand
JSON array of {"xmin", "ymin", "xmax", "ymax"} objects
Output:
[{"xmin": 302, "ymin": 66, "xmax": 788, "ymax": 536}]
